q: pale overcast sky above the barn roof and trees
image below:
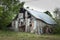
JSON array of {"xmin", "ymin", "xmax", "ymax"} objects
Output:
[{"xmin": 20, "ymin": 0, "xmax": 60, "ymax": 17}]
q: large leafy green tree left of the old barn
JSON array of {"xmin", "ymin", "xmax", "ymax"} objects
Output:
[{"xmin": 0, "ymin": 0, "xmax": 24, "ymax": 29}]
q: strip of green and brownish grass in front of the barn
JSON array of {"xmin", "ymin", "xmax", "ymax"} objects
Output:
[{"xmin": 0, "ymin": 30, "xmax": 60, "ymax": 40}]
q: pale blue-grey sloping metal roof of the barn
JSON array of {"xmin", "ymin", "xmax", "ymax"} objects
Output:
[{"xmin": 26, "ymin": 9, "xmax": 56, "ymax": 24}]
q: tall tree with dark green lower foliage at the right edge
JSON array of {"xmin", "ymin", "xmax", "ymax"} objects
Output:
[{"xmin": 54, "ymin": 8, "xmax": 60, "ymax": 34}]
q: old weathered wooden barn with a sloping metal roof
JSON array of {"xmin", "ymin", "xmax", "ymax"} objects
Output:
[{"xmin": 9, "ymin": 8, "xmax": 56, "ymax": 34}]
